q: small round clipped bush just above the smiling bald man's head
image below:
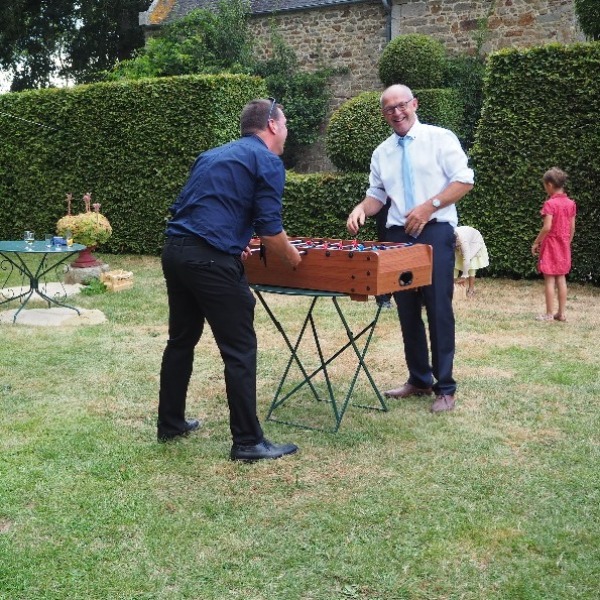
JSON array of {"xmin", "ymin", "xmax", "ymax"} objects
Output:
[{"xmin": 379, "ymin": 33, "xmax": 445, "ymax": 88}]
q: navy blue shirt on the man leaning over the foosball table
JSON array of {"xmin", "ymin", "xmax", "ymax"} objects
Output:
[{"xmin": 166, "ymin": 135, "xmax": 285, "ymax": 256}]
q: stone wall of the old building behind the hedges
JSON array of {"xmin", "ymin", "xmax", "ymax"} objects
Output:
[{"xmin": 140, "ymin": 0, "xmax": 583, "ymax": 171}]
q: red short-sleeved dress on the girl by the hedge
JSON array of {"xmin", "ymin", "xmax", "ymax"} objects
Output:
[{"xmin": 538, "ymin": 193, "xmax": 577, "ymax": 275}]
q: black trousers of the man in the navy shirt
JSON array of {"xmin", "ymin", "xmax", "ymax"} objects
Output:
[{"xmin": 158, "ymin": 237, "xmax": 263, "ymax": 444}]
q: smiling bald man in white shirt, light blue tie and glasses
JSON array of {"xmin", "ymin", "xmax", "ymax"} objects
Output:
[{"xmin": 347, "ymin": 85, "xmax": 474, "ymax": 413}]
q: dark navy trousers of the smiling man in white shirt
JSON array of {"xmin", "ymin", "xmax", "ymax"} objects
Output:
[{"xmin": 387, "ymin": 222, "xmax": 456, "ymax": 395}]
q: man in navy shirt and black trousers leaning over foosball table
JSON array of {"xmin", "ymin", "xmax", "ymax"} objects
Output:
[{"xmin": 158, "ymin": 98, "xmax": 301, "ymax": 461}]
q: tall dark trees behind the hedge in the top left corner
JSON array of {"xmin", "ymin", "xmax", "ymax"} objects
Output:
[{"xmin": 0, "ymin": 0, "xmax": 150, "ymax": 91}]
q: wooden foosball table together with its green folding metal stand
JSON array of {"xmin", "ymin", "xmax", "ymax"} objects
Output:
[{"xmin": 245, "ymin": 237, "xmax": 432, "ymax": 432}]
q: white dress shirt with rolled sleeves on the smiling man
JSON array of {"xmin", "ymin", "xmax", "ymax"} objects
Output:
[{"xmin": 367, "ymin": 119, "xmax": 474, "ymax": 228}]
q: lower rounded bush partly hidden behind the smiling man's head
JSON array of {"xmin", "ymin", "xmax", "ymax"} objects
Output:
[{"xmin": 325, "ymin": 89, "xmax": 463, "ymax": 172}]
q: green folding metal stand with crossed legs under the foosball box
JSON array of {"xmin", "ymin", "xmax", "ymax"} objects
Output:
[{"xmin": 250, "ymin": 284, "xmax": 388, "ymax": 433}]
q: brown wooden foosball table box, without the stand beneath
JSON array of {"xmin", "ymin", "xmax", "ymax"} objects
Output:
[{"xmin": 244, "ymin": 237, "xmax": 433, "ymax": 301}]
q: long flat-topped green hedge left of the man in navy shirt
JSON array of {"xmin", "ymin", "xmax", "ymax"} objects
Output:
[{"xmin": 0, "ymin": 75, "xmax": 267, "ymax": 254}]
